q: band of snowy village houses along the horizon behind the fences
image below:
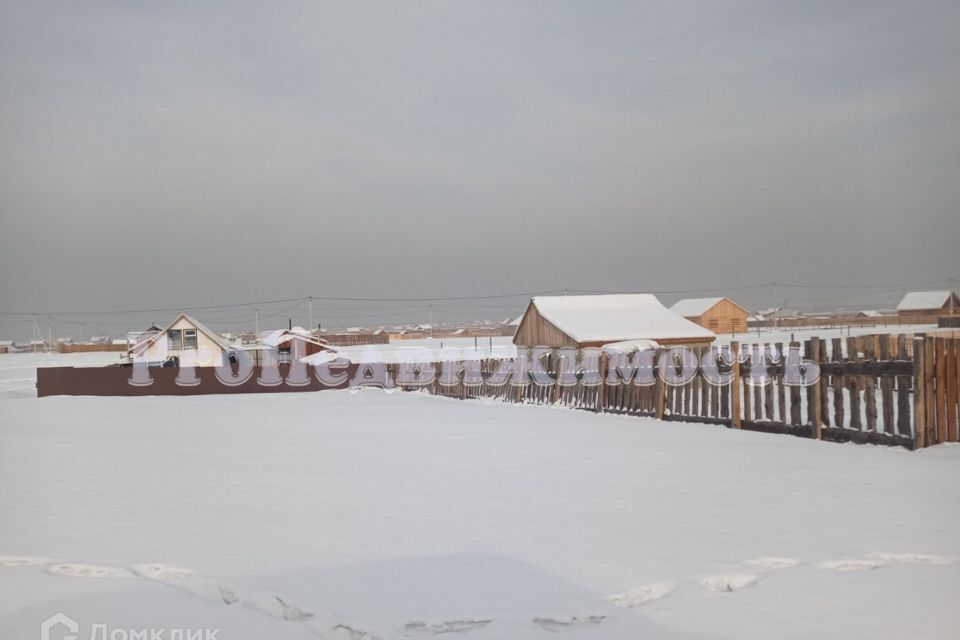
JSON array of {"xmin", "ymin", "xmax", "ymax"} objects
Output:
[{"xmin": 0, "ymin": 291, "xmax": 960, "ymax": 366}]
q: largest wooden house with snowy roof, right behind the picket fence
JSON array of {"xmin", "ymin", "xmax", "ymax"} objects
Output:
[{"xmin": 513, "ymin": 293, "xmax": 716, "ymax": 347}]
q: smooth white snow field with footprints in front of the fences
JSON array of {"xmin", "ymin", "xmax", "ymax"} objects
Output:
[{"xmin": 0, "ymin": 372, "xmax": 960, "ymax": 640}]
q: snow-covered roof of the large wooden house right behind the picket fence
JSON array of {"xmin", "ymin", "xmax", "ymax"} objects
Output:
[{"xmin": 531, "ymin": 293, "xmax": 716, "ymax": 342}]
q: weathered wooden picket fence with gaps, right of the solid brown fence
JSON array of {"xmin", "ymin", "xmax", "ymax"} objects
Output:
[{"xmin": 402, "ymin": 334, "xmax": 960, "ymax": 449}]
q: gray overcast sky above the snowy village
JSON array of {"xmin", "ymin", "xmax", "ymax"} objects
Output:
[{"xmin": 0, "ymin": 1, "xmax": 960, "ymax": 338}]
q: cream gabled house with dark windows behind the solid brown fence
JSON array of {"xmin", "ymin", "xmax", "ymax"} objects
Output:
[{"xmin": 127, "ymin": 313, "xmax": 230, "ymax": 367}]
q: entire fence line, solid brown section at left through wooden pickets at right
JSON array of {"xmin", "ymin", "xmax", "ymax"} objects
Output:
[{"xmin": 37, "ymin": 332, "xmax": 960, "ymax": 449}]
